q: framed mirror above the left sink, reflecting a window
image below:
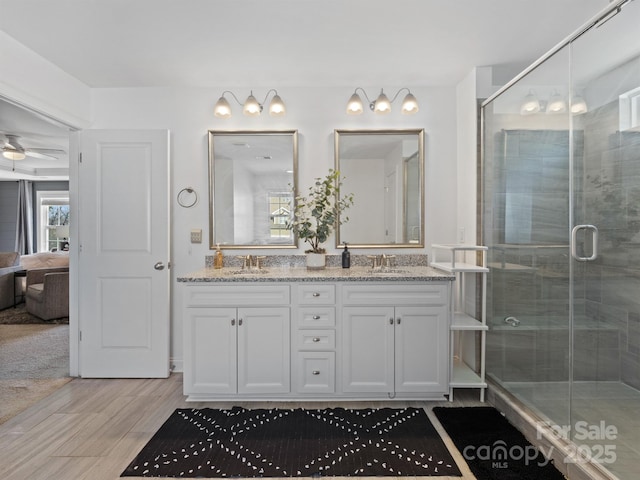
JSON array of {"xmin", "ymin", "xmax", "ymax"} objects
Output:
[{"xmin": 209, "ymin": 130, "xmax": 298, "ymax": 249}]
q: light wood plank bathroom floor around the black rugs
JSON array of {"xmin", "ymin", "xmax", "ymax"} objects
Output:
[{"xmin": 0, "ymin": 374, "xmax": 480, "ymax": 480}]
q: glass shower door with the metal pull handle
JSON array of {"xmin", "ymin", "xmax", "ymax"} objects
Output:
[{"xmin": 569, "ymin": 2, "xmax": 640, "ymax": 479}]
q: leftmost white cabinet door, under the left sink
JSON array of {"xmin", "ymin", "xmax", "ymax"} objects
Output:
[{"xmin": 184, "ymin": 308, "xmax": 237, "ymax": 395}]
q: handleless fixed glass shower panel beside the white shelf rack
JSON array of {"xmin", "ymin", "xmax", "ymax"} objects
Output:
[{"xmin": 483, "ymin": 48, "xmax": 575, "ymax": 425}]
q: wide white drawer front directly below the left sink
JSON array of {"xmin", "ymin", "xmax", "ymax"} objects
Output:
[{"xmin": 184, "ymin": 285, "xmax": 290, "ymax": 307}]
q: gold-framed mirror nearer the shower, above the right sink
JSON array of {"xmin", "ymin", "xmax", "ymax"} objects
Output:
[{"xmin": 334, "ymin": 129, "xmax": 424, "ymax": 248}]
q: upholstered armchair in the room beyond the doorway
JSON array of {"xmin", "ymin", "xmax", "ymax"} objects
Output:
[{"xmin": 25, "ymin": 267, "xmax": 69, "ymax": 320}]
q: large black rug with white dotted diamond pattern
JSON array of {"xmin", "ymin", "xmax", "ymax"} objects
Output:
[{"xmin": 121, "ymin": 407, "xmax": 461, "ymax": 478}]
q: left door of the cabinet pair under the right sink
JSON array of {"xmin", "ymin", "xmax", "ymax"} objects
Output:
[{"xmin": 342, "ymin": 306, "xmax": 394, "ymax": 392}]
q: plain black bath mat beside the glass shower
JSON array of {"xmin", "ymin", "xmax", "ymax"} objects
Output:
[{"xmin": 433, "ymin": 407, "xmax": 565, "ymax": 480}]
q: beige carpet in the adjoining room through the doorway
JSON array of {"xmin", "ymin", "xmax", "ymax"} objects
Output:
[{"xmin": 0, "ymin": 324, "xmax": 71, "ymax": 424}]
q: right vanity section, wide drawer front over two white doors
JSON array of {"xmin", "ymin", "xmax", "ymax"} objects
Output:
[{"xmin": 342, "ymin": 282, "xmax": 449, "ymax": 397}]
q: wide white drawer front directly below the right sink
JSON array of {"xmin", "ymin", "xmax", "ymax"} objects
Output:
[{"xmin": 342, "ymin": 282, "xmax": 448, "ymax": 305}]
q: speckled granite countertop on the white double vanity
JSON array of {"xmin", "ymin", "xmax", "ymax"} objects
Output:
[{"xmin": 178, "ymin": 265, "xmax": 455, "ymax": 283}]
